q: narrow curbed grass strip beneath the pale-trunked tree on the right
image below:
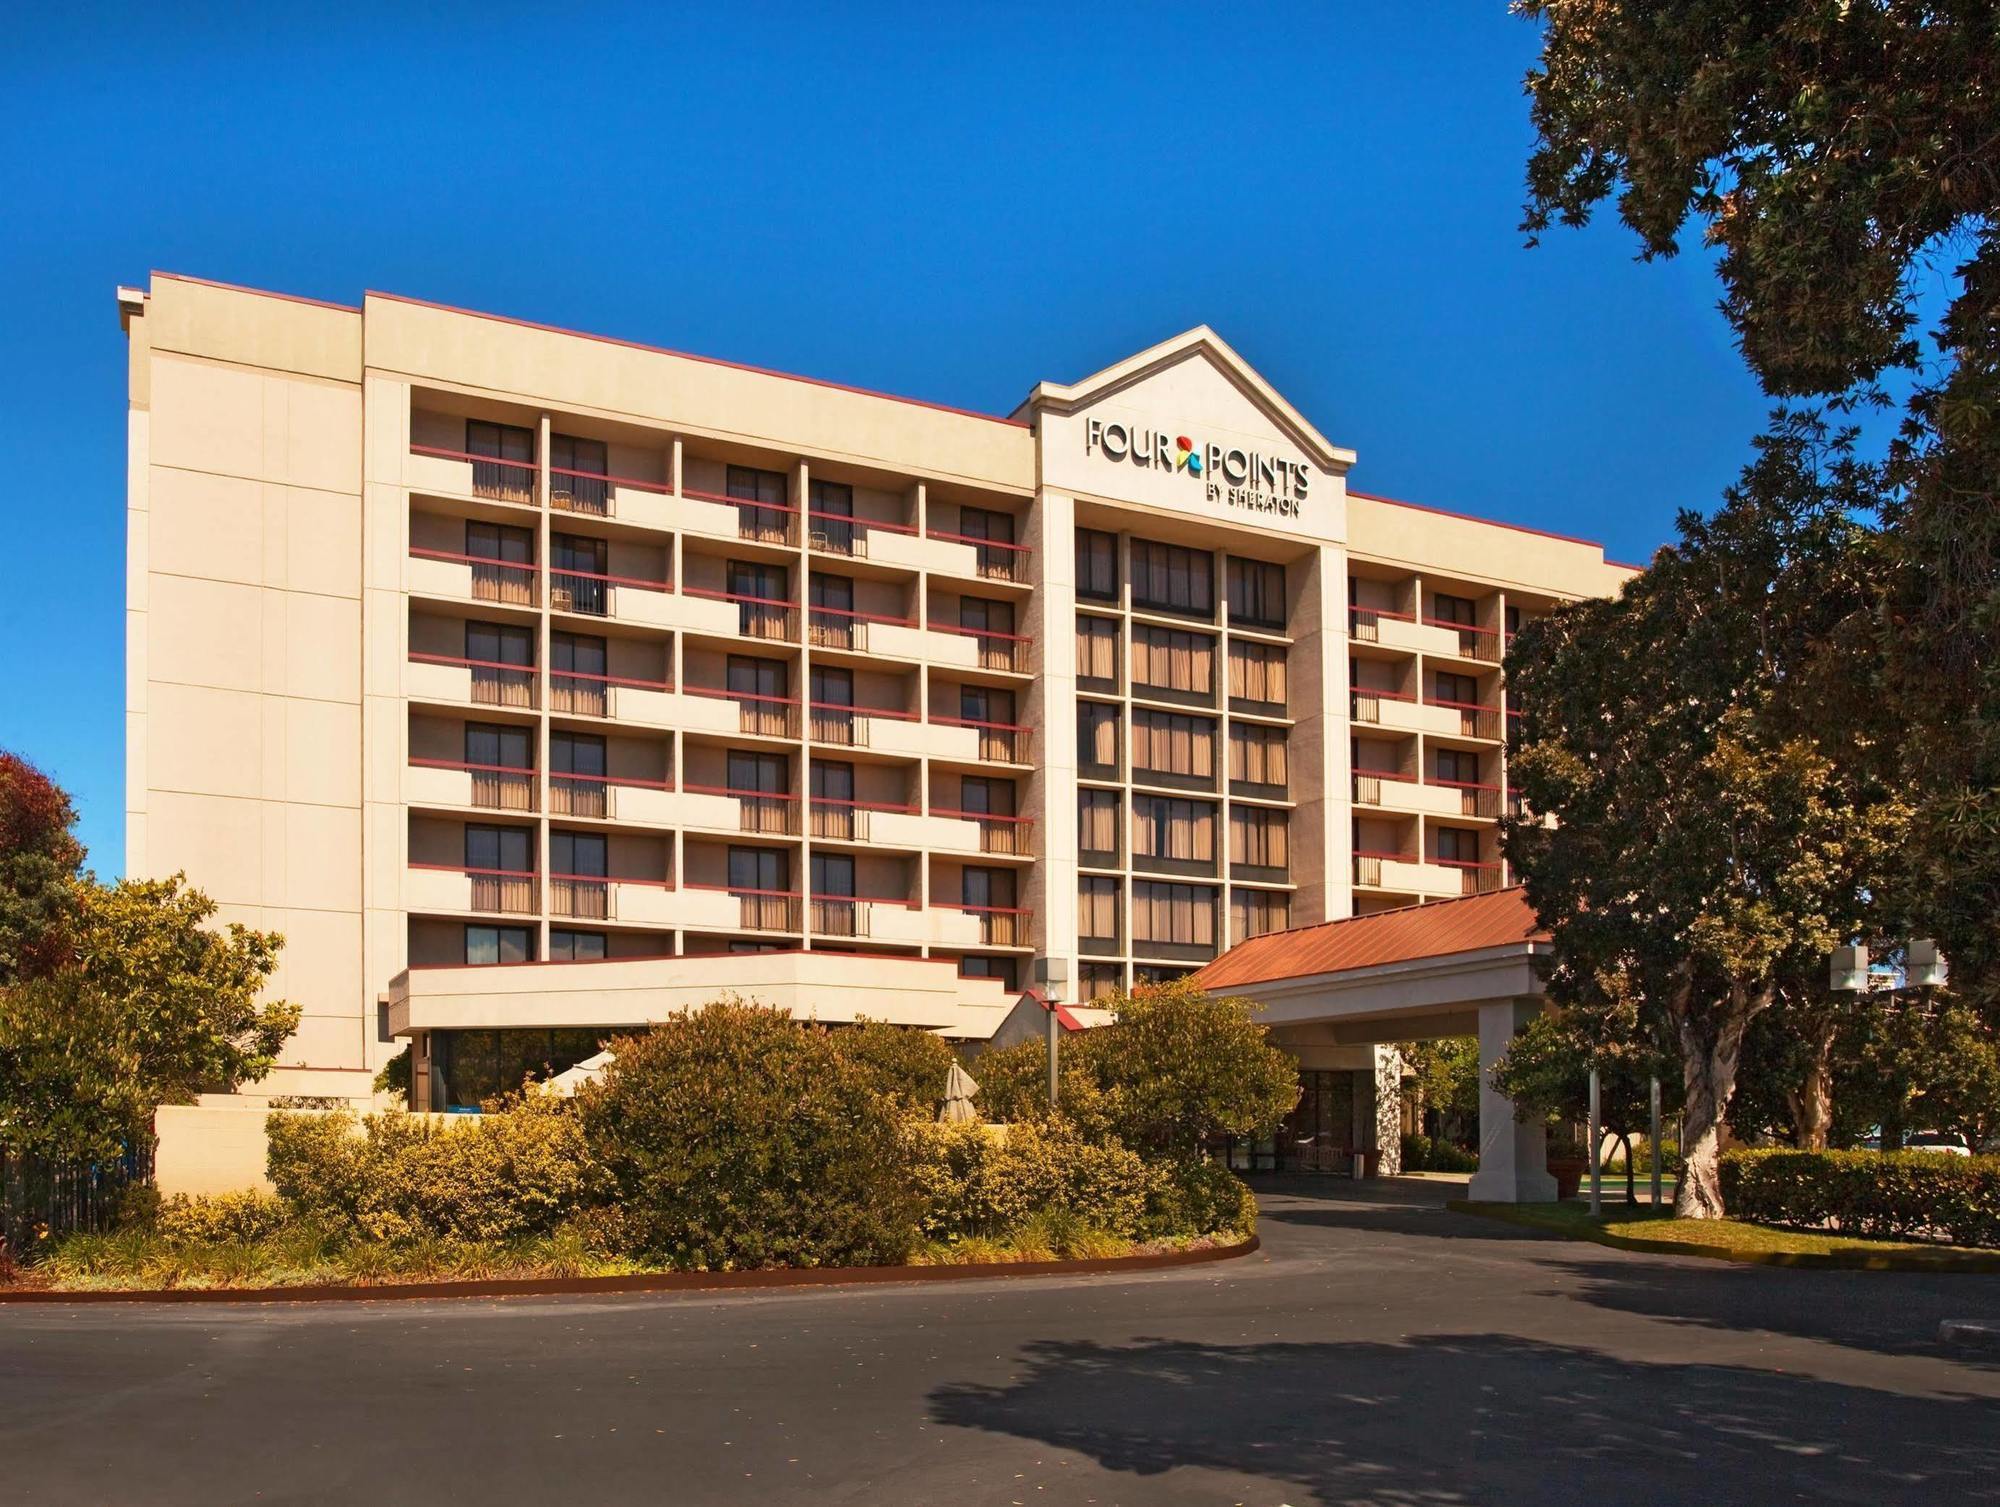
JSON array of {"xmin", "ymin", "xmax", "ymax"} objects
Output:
[{"xmin": 1452, "ymin": 1201, "xmax": 2000, "ymax": 1271}]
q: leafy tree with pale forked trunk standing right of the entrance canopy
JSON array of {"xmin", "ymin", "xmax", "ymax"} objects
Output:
[{"xmin": 1504, "ymin": 414, "xmax": 1900, "ymax": 1217}]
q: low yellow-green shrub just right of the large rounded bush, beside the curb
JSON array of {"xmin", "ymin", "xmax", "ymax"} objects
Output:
[{"xmin": 908, "ymin": 1115, "xmax": 1158, "ymax": 1241}]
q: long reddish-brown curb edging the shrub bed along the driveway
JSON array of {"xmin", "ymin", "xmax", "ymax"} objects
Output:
[{"xmin": 0, "ymin": 1235, "xmax": 1264, "ymax": 1303}]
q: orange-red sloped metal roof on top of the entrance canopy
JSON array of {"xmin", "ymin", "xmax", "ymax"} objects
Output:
[{"xmin": 1194, "ymin": 885, "xmax": 1548, "ymax": 989}]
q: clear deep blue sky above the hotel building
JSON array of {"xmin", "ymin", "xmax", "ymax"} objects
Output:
[{"xmin": 0, "ymin": 0, "xmax": 1764, "ymax": 873}]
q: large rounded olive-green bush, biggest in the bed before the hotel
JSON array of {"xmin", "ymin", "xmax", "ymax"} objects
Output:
[{"xmin": 576, "ymin": 1003, "xmax": 918, "ymax": 1269}]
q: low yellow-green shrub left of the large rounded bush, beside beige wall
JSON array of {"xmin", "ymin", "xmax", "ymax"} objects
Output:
[{"xmin": 266, "ymin": 1095, "xmax": 600, "ymax": 1243}]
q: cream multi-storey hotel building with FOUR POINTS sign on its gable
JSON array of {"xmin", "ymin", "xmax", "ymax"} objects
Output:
[{"xmin": 118, "ymin": 274, "xmax": 1628, "ymax": 1107}]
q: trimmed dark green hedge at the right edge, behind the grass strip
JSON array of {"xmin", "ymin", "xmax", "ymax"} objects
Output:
[{"xmin": 1722, "ymin": 1149, "xmax": 2000, "ymax": 1247}]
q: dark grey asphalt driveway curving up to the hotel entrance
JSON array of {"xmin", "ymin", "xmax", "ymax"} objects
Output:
[{"xmin": 0, "ymin": 1179, "xmax": 2000, "ymax": 1507}]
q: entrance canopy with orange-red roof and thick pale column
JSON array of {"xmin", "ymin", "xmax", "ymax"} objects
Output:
[{"xmin": 1194, "ymin": 887, "xmax": 1556, "ymax": 1203}]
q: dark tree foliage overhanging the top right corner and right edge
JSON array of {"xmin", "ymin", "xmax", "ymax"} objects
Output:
[{"xmin": 1516, "ymin": 0, "xmax": 2000, "ymax": 1011}]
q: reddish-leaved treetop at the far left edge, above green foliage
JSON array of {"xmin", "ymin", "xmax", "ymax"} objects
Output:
[{"xmin": 0, "ymin": 752, "xmax": 84, "ymax": 989}]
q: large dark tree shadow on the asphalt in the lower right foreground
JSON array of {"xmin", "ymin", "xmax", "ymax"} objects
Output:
[{"xmin": 930, "ymin": 1335, "xmax": 2000, "ymax": 1505}]
